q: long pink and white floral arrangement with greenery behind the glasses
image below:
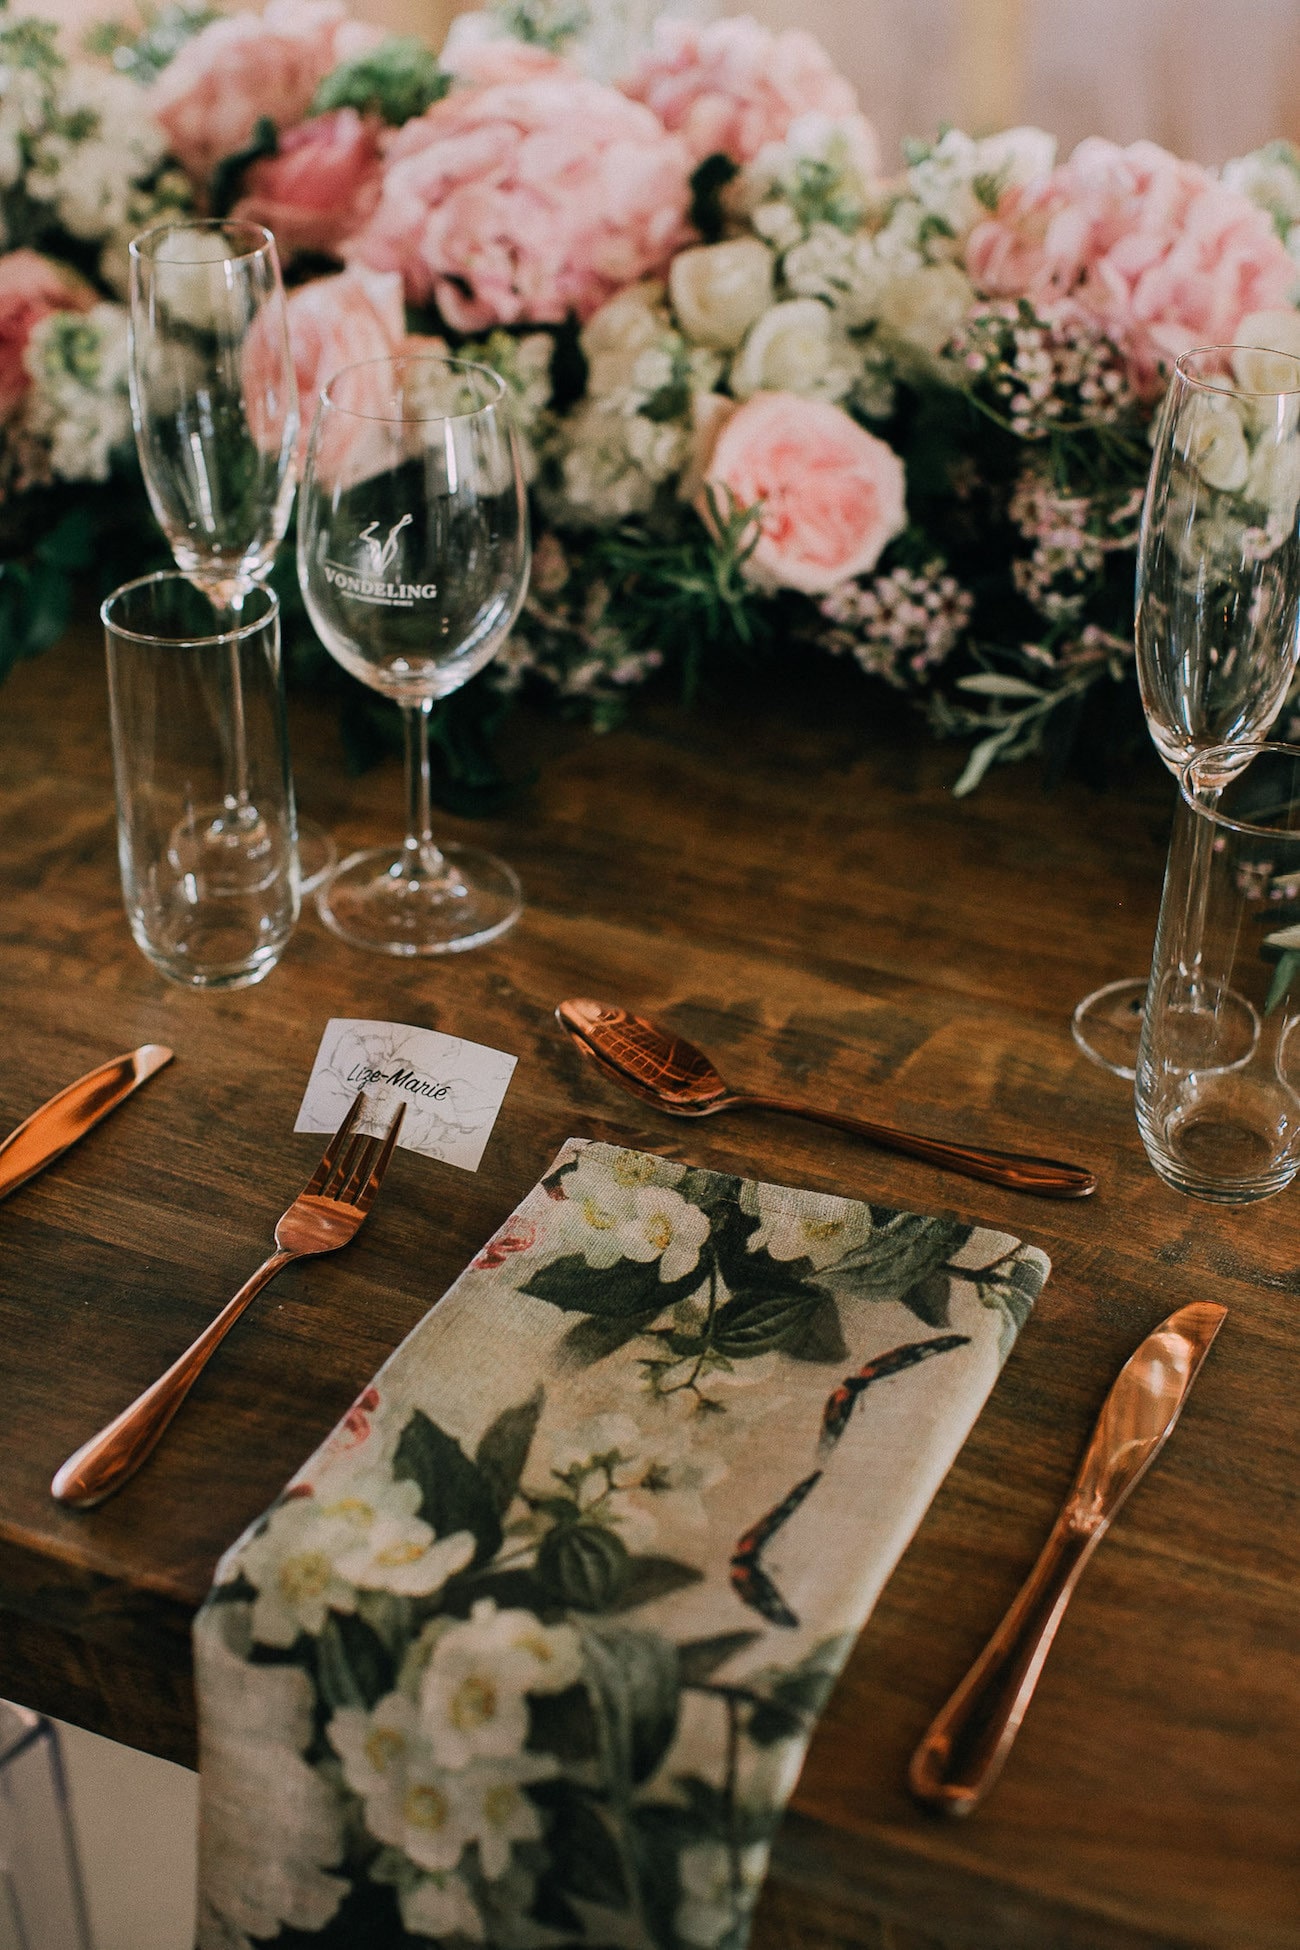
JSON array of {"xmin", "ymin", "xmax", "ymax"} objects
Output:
[{"xmin": 0, "ymin": 0, "xmax": 1300, "ymax": 790}]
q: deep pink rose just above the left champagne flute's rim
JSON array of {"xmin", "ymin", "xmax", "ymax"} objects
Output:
[{"xmin": 232, "ymin": 109, "xmax": 382, "ymax": 257}]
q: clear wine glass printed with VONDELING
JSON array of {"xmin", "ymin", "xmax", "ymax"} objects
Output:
[{"xmin": 298, "ymin": 357, "xmax": 528, "ymax": 956}]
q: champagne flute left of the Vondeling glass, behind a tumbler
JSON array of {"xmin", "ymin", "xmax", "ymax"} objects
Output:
[{"xmin": 129, "ymin": 218, "xmax": 337, "ymax": 887}]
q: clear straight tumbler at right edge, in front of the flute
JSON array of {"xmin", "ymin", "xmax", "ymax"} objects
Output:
[{"xmin": 1136, "ymin": 745, "xmax": 1300, "ymax": 1205}]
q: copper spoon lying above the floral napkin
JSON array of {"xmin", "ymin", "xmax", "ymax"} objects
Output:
[{"xmin": 555, "ymin": 996, "xmax": 1097, "ymax": 1199}]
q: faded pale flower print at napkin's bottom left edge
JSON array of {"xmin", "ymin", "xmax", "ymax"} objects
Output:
[{"xmin": 195, "ymin": 1607, "xmax": 349, "ymax": 1950}]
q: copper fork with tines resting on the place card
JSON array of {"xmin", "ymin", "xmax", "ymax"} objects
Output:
[{"xmin": 51, "ymin": 1092, "xmax": 405, "ymax": 1509}]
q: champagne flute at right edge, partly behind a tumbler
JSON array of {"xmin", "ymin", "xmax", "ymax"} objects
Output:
[{"xmin": 1072, "ymin": 345, "xmax": 1300, "ymax": 1078}]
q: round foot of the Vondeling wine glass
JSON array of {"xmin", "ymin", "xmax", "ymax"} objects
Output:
[{"xmin": 316, "ymin": 846, "xmax": 524, "ymax": 956}]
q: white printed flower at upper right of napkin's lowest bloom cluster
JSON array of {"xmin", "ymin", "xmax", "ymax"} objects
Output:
[{"xmin": 419, "ymin": 1599, "xmax": 583, "ymax": 1767}]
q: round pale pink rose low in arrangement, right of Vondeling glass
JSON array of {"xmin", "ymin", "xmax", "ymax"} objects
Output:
[{"xmin": 704, "ymin": 392, "xmax": 906, "ymax": 595}]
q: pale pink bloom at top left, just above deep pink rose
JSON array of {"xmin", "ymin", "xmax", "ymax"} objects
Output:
[{"xmin": 148, "ymin": 0, "xmax": 382, "ymax": 183}]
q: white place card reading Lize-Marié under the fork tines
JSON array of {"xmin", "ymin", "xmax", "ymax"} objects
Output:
[{"xmin": 294, "ymin": 1016, "xmax": 516, "ymax": 1172}]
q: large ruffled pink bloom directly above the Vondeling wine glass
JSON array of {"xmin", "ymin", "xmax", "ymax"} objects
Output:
[{"xmin": 345, "ymin": 64, "xmax": 690, "ymax": 332}]
